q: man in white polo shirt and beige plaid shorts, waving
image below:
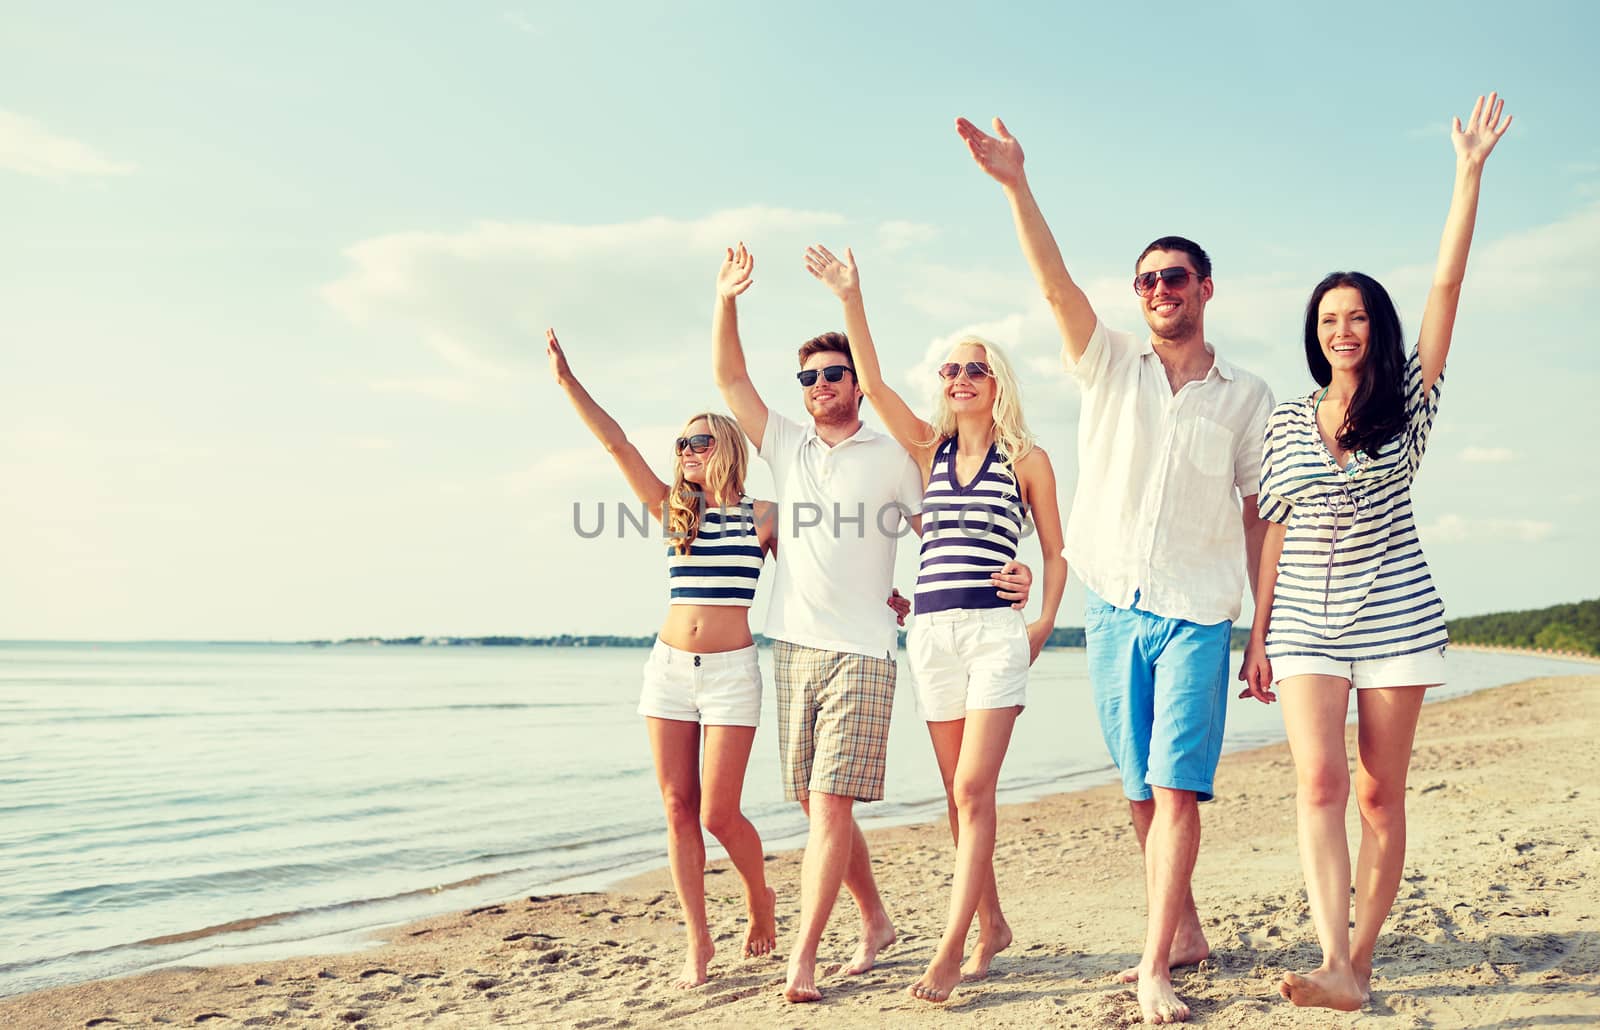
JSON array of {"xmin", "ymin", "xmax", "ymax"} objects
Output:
[{"xmin": 712, "ymin": 243, "xmax": 1030, "ymax": 1001}]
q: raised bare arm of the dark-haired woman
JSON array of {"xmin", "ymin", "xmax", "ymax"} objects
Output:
[{"xmin": 1416, "ymin": 93, "xmax": 1510, "ymax": 397}]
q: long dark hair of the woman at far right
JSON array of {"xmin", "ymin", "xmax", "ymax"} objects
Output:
[{"xmin": 1306, "ymin": 272, "xmax": 1405, "ymax": 456}]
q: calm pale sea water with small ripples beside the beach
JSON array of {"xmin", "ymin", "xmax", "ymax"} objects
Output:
[{"xmin": 0, "ymin": 643, "xmax": 1578, "ymax": 995}]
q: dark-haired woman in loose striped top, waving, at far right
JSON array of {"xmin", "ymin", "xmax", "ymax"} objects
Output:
[{"xmin": 1240, "ymin": 93, "xmax": 1510, "ymax": 1011}]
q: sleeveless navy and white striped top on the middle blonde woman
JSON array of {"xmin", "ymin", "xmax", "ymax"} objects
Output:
[{"xmin": 915, "ymin": 437, "xmax": 1027, "ymax": 614}]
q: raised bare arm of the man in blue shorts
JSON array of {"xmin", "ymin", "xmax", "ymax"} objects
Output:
[{"xmin": 955, "ymin": 118, "xmax": 1098, "ymax": 365}]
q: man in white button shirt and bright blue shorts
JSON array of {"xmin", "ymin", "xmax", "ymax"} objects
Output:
[{"xmin": 957, "ymin": 118, "xmax": 1272, "ymax": 1024}]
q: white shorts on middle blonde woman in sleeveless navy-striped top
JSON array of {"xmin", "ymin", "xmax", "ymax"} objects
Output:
[{"xmin": 906, "ymin": 608, "xmax": 1029, "ymax": 723}]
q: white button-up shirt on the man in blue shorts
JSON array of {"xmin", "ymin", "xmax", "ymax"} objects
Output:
[{"xmin": 1062, "ymin": 323, "xmax": 1272, "ymax": 625}]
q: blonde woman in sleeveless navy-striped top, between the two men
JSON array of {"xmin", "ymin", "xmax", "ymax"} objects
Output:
[{"xmin": 805, "ymin": 246, "xmax": 1067, "ymax": 1001}]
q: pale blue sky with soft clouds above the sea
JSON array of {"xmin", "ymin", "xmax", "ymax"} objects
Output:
[{"xmin": 0, "ymin": 0, "xmax": 1600, "ymax": 640}]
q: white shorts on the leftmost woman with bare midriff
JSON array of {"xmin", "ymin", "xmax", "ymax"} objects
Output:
[{"xmin": 638, "ymin": 640, "xmax": 762, "ymax": 726}]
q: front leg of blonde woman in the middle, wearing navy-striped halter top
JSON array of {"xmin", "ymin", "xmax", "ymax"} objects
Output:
[{"xmin": 910, "ymin": 707, "xmax": 1018, "ymax": 1001}]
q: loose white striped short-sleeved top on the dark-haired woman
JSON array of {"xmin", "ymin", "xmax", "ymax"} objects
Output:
[{"xmin": 1258, "ymin": 350, "xmax": 1448, "ymax": 662}]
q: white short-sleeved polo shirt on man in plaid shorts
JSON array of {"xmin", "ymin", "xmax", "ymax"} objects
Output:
[{"xmin": 757, "ymin": 409, "xmax": 922, "ymax": 659}]
